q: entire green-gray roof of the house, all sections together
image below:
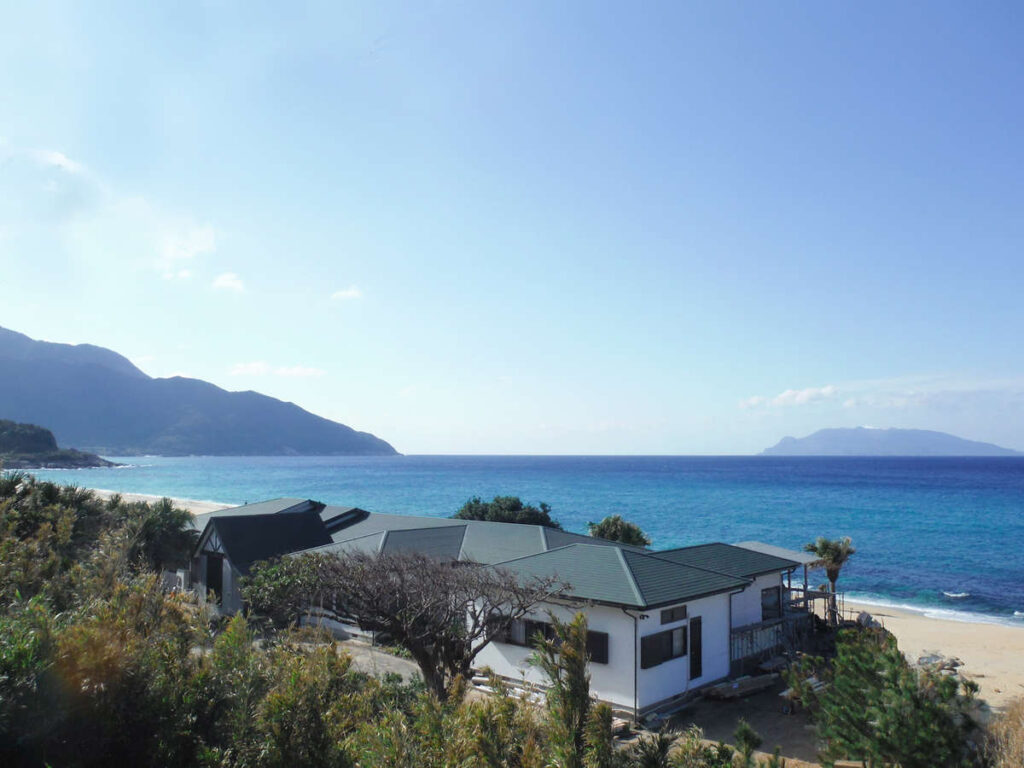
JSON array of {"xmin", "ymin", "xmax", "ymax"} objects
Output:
[{"xmin": 199, "ymin": 499, "xmax": 802, "ymax": 608}]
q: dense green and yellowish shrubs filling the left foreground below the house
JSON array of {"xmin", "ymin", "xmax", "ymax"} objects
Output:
[{"xmin": 0, "ymin": 474, "xmax": 786, "ymax": 768}]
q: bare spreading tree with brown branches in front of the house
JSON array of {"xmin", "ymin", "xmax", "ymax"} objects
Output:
[{"xmin": 245, "ymin": 553, "xmax": 565, "ymax": 699}]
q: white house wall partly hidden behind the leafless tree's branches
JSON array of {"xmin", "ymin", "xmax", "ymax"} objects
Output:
[{"xmin": 473, "ymin": 604, "xmax": 634, "ymax": 710}]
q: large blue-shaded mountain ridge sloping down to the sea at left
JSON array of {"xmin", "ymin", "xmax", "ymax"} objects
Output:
[{"xmin": 0, "ymin": 328, "xmax": 397, "ymax": 456}]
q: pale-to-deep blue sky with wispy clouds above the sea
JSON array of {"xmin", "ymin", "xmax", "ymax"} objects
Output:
[{"xmin": 0, "ymin": 2, "xmax": 1024, "ymax": 454}]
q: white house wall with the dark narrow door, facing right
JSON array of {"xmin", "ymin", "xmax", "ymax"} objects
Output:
[{"xmin": 636, "ymin": 592, "xmax": 733, "ymax": 710}]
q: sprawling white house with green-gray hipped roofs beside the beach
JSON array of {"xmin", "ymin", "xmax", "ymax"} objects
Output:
[{"xmin": 193, "ymin": 499, "xmax": 806, "ymax": 717}]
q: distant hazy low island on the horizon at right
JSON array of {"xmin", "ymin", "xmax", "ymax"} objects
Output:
[{"xmin": 761, "ymin": 427, "xmax": 1024, "ymax": 456}]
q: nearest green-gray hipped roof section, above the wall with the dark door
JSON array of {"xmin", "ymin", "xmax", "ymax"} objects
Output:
[{"xmin": 495, "ymin": 543, "xmax": 750, "ymax": 608}]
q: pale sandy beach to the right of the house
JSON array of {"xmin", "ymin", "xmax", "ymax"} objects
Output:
[{"xmin": 846, "ymin": 601, "xmax": 1024, "ymax": 711}]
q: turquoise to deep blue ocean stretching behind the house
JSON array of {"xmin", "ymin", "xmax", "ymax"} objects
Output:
[{"xmin": 24, "ymin": 456, "xmax": 1024, "ymax": 626}]
